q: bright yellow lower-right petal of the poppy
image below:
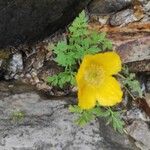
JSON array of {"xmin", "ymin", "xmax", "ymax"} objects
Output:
[{"xmin": 97, "ymin": 77, "xmax": 123, "ymax": 106}]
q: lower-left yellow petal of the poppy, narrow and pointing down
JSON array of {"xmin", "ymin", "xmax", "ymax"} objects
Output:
[{"xmin": 78, "ymin": 82, "xmax": 96, "ymax": 109}]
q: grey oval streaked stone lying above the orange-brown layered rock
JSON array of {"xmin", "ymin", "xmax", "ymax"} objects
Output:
[{"xmin": 110, "ymin": 9, "xmax": 143, "ymax": 26}]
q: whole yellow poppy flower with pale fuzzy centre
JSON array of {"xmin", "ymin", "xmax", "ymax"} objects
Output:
[{"xmin": 76, "ymin": 52, "xmax": 123, "ymax": 109}]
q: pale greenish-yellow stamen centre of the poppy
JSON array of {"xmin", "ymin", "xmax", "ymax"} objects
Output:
[{"xmin": 84, "ymin": 64, "xmax": 104, "ymax": 86}]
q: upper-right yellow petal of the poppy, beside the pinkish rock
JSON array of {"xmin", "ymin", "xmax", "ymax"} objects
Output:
[{"xmin": 83, "ymin": 52, "xmax": 121, "ymax": 75}]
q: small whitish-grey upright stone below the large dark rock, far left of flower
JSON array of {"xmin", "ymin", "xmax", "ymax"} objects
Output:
[{"xmin": 4, "ymin": 53, "xmax": 23, "ymax": 80}]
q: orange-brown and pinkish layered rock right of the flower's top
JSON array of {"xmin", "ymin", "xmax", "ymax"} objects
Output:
[{"xmin": 89, "ymin": 22, "xmax": 150, "ymax": 65}]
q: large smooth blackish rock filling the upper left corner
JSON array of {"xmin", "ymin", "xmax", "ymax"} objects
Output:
[{"xmin": 0, "ymin": 0, "xmax": 90, "ymax": 47}]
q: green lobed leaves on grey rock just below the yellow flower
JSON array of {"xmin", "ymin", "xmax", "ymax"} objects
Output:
[{"xmin": 69, "ymin": 105, "xmax": 124, "ymax": 133}]
